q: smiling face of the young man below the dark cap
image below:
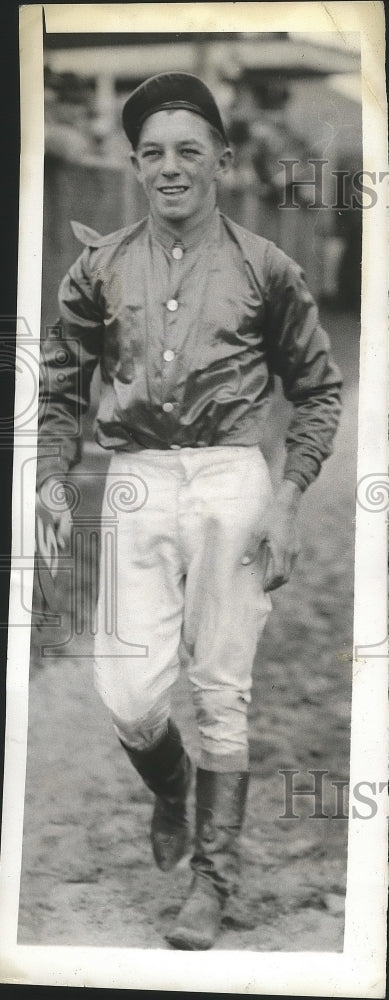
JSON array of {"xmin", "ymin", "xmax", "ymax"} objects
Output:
[{"xmin": 131, "ymin": 109, "xmax": 231, "ymax": 229}]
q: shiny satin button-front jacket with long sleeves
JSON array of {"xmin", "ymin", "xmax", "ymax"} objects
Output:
[{"xmin": 38, "ymin": 211, "xmax": 341, "ymax": 489}]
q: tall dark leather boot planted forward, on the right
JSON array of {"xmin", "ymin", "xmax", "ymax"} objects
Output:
[{"xmin": 166, "ymin": 768, "xmax": 249, "ymax": 951}]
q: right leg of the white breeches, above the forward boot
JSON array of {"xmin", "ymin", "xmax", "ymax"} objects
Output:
[{"xmin": 182, "ymin": 448, "xmax": 272, "ymax": 771}]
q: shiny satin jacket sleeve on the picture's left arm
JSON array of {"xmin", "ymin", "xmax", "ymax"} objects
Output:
[{"xmin": 37, "ymin": 248, "xmax": 104, "ymax": 489}]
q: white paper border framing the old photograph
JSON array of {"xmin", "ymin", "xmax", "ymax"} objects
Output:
[{"xmin": 0, "ymin": 2, "xmax": 388, "ymax": 997}]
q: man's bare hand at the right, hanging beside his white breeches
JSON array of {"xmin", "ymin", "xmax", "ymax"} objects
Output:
[{"xmin": 242, "ymin": 479, "xmax": 302, "ymax": 592}]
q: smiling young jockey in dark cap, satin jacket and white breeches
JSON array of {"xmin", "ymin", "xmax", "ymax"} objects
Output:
[{"xmin": 38, "ymin": 73, "xmax": 341, "ymax": 949}]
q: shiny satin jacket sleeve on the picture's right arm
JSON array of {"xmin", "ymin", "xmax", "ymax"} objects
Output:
[{"xmin": 265, "ymin": 245, "xmax": 342, "ymax": 490}]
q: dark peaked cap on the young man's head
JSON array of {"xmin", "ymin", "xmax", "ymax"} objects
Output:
[{"xmin": 123, "ymin": 73, "xmax": 228, "ymax": 149}]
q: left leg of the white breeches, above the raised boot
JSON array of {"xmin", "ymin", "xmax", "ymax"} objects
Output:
[{"xmin": 94, "ymin": 452, "xmax": 183, "ymax": 749}]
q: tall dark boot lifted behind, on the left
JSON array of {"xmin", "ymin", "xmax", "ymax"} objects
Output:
[{"xmin": 120, "ymin": 720, "xmax": 191, "ymax": 872}]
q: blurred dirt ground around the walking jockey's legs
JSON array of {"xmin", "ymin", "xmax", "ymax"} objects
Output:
[{"xmin": 19, "ymin": 314, "xmax": 359, "ymax": 951}]
